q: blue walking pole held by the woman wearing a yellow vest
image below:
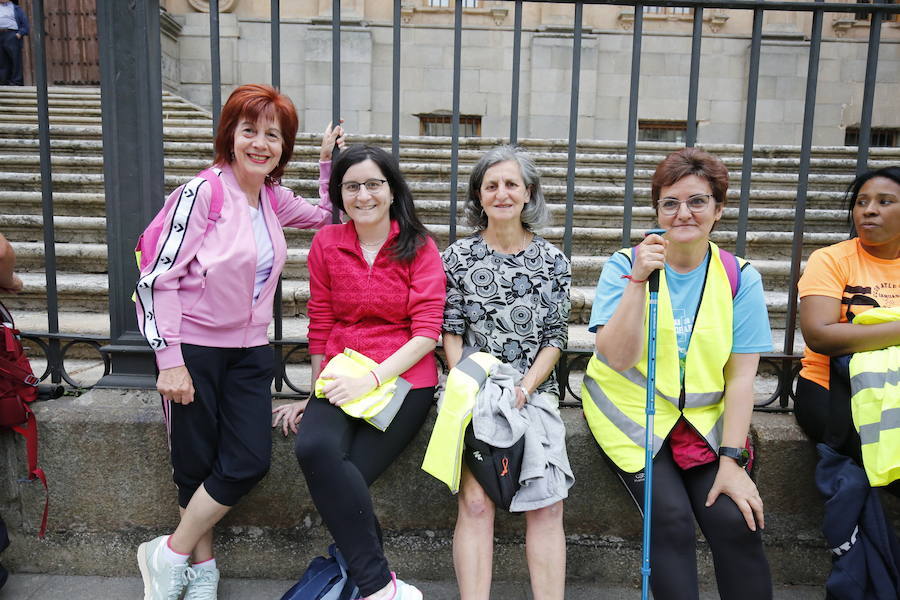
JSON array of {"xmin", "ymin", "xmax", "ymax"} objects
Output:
[{"xmin": 641, "ymin": 229, "xmax": 665, "ymax": 600}]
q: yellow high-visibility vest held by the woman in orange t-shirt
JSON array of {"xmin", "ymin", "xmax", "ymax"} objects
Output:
[{"xmin": 850, "ymin": 307, "xmax": 900, "ymax": 486}]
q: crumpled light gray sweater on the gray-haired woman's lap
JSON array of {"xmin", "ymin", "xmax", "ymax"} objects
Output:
[{"xmin": 472, "ymin": 363, "xmax": 575, "ymax": 512}]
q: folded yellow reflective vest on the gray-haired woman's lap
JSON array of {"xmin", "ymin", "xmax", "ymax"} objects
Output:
[{"xmin": 422, "ymin": 352, "xmax": 500, "ymax": 494}]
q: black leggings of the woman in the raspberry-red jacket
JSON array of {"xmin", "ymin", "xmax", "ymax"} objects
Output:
[{"xmin": 294, "ymin": 387, "xmax": 434, "ymax": 597}]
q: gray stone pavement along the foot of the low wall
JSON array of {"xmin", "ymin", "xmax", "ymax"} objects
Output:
[{"xmin": 0, "ymin": 574, "xmax": 824, "ymax": 600}]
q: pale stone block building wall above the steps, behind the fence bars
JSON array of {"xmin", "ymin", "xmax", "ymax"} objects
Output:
[{"xmin": 163, "ymin": 13, "xmax": 900, "ymax": 145}]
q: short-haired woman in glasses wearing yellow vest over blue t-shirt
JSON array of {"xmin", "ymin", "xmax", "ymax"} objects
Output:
[{"xmin": 582, "ymin": 148, "xmax": 772, "ymax": 600}]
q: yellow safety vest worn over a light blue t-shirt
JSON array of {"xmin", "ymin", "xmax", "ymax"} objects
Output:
[{"xmin": 581, "ymin": 242, "xmax": 746, "ymax": 473}]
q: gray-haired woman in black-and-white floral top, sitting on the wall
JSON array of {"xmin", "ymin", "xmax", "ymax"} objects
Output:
[{"xmin": 442, "ymin": 146, "xmax": 571, "ymax": 600}]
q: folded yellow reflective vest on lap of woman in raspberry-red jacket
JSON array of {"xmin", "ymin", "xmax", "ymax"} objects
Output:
[{"xmin": 315, "ymin": 348, "xmax": 411, "ymax": 431}]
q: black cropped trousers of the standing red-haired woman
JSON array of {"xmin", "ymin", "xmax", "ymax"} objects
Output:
[{"xmin": 167, "ymin": 344, "xmax": 274, "ymax": 508}]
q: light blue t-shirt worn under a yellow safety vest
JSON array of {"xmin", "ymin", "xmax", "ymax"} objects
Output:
[{"xmin": 588, "ymin": 252, "xmax": 772, "ymax": 367}]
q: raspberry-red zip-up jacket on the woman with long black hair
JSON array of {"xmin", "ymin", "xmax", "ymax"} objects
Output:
[{"xmin": 307, "ymin": 221, "xmax": 447, "ymax": 389}]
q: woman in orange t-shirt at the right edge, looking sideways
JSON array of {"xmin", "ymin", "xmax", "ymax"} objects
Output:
[{"xmin": 794, "ymin": 167, "xmax": 900, "ymax": 456}]
